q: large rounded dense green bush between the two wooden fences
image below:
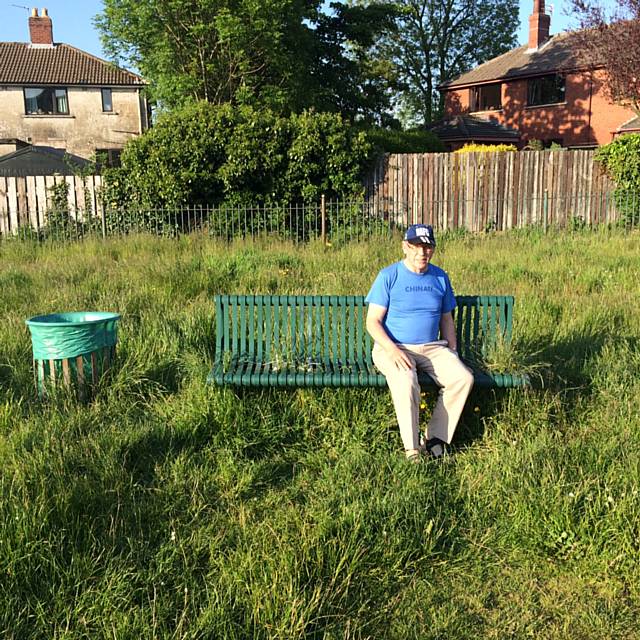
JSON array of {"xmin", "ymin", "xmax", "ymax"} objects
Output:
[{"xmin": 104, "ymin": 101, "xmax": 371, "ymax": 209}]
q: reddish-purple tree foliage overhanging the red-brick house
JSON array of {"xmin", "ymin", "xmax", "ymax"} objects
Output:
[{"xmin": 571, "ymin": 0, "xmax": 640, "ymax": 115}]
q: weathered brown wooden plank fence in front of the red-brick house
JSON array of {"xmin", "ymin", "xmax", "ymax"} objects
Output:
[{"xmin": 365, "ymin": 150, "xmax": 619, "ymax": 231}]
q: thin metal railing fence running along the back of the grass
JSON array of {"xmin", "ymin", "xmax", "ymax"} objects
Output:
[{"xmin": 0, "ymin": 192, "xmax": 640, "ymax": 242}]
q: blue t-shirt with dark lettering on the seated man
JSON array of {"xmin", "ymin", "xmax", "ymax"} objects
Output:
[{"xmin": 365, "ymin": 262, "xmax": 456, "ymax": 344}]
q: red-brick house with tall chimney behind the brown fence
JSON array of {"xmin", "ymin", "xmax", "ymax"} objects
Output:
[{"xmin": 434, "ymin": 0, "xmax": 640, "ymax": 149}]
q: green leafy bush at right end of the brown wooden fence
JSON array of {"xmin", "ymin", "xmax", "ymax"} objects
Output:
[{"xmin": 595, "ymin": 133, "xmax": 640, "ymax": 223}]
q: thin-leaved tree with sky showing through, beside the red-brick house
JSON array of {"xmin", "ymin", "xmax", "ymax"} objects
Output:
[{"xmin": 378, "ymin": 0, "xmax": 518, "ymax": 125}]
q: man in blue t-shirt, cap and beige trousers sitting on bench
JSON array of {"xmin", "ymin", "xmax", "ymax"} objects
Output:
[{"xmin": 366, "ymin": 224, "xmax": 473, "ymax": 462}]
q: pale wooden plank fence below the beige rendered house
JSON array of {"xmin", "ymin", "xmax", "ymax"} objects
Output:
[{"xmin": 0, "ymin": 176, "xmax": 102, "ymax": 235}]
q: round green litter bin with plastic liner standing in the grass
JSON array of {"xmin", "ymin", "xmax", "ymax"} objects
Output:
[{"xmin": 26, "ymin": 311, "xmax": 120, "ymax": 398}]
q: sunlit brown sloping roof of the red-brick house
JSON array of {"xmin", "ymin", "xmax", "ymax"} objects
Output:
[{"xmin": 438, "ymin": 33, "xmax": 594, "ymax": 90}]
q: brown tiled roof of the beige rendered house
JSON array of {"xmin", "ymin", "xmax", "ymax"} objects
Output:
[{"xmin": 0, "ymin": 42, "xmax": 145, "ymax": 86}]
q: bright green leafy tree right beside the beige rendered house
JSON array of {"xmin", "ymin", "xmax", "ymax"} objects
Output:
[{"xmin": 96, "ymin": 0, "xmax": 318, "ymax": 107}]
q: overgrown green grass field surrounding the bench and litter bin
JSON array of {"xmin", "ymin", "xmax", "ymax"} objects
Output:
[{"xmin": 0, "ymin": 230, "xmax": 640, "ymax": 640}]
